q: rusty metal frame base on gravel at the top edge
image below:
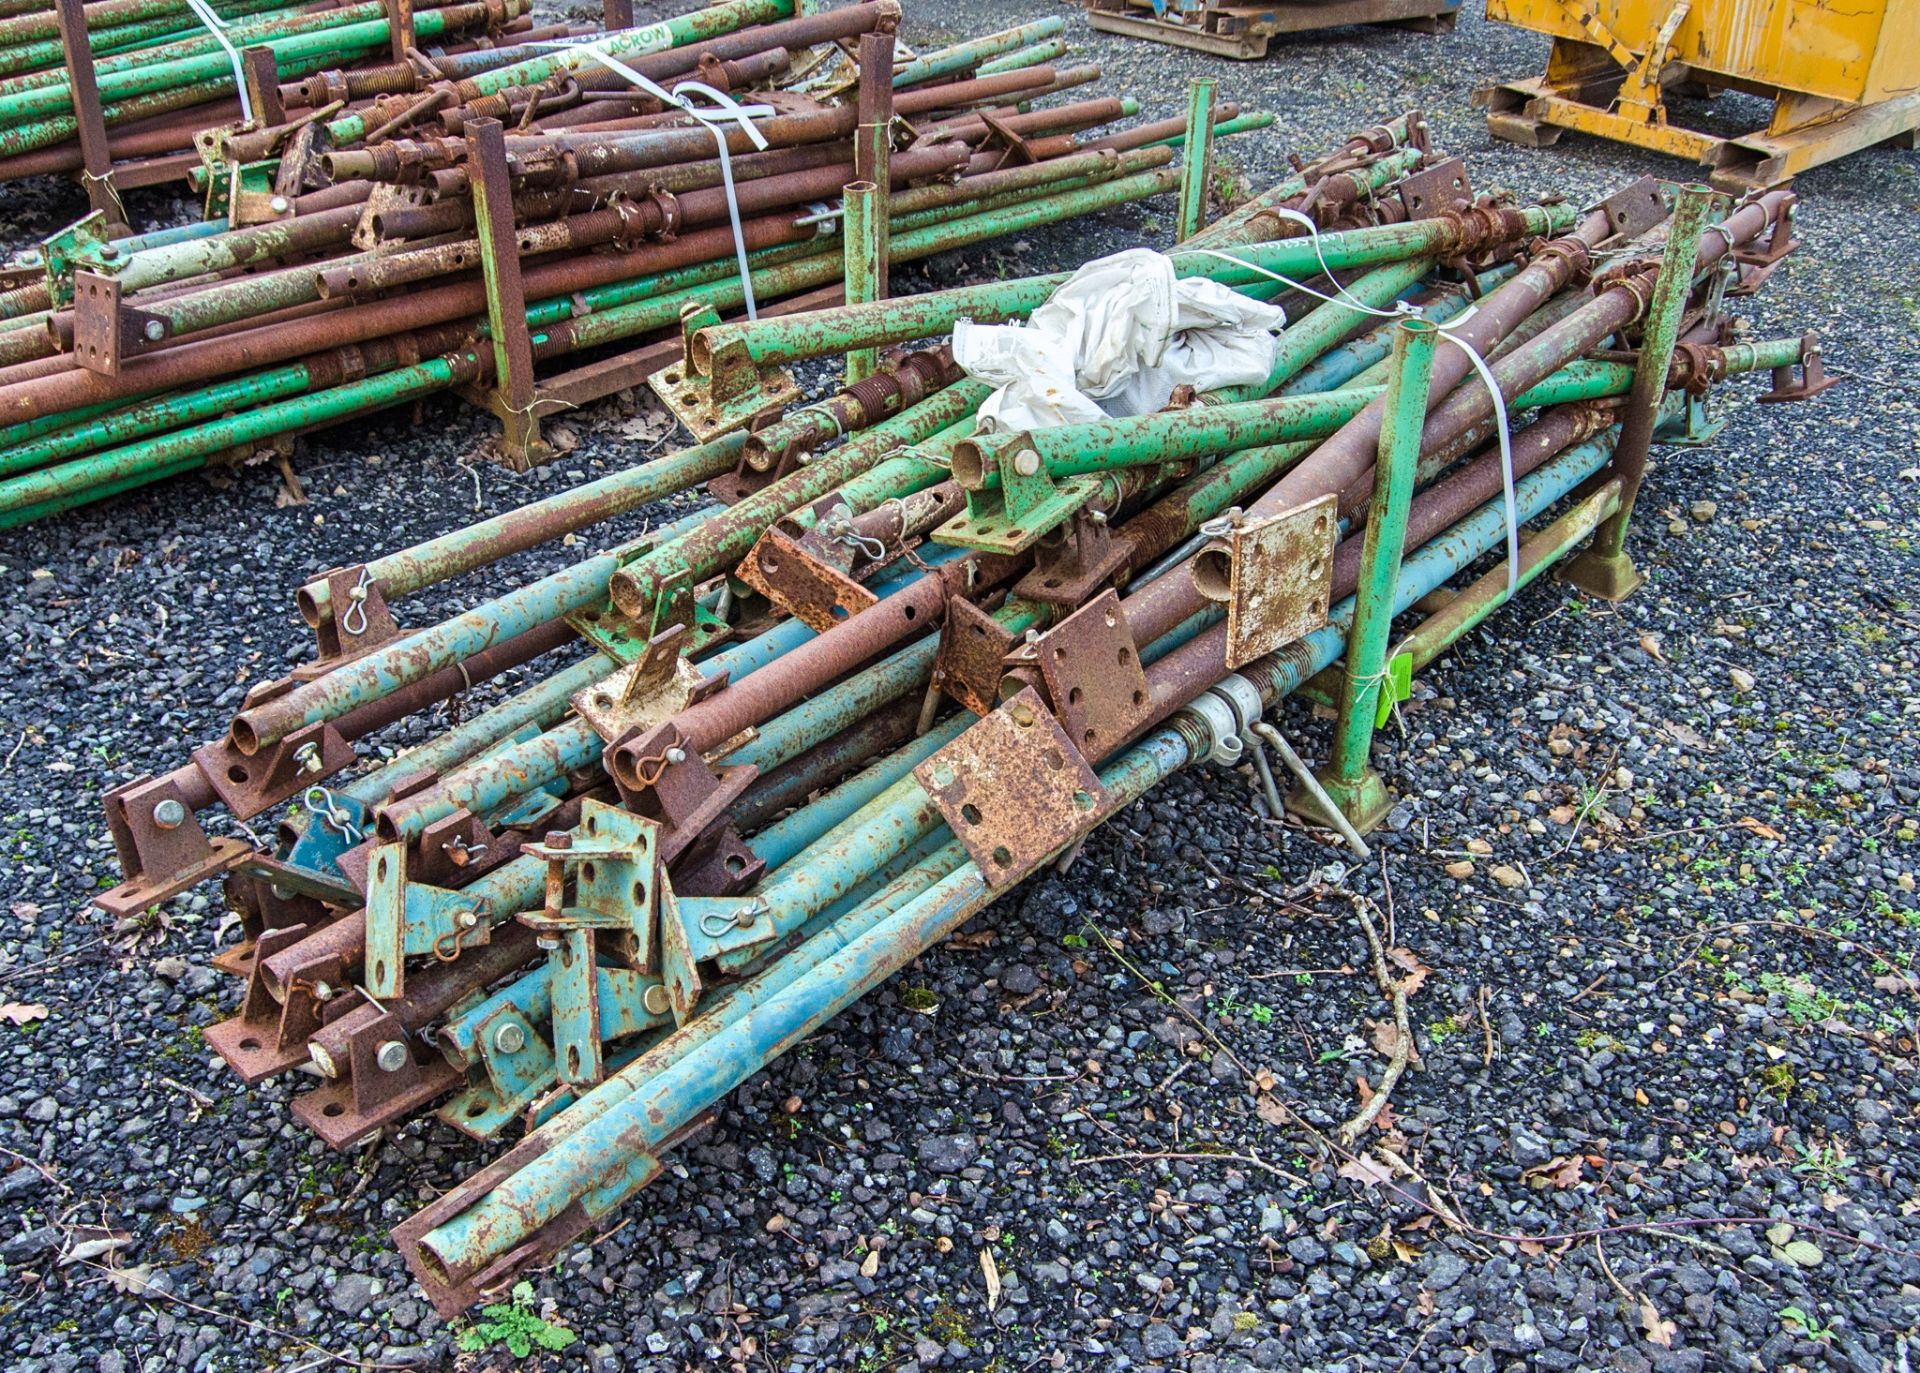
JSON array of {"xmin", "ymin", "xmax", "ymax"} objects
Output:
[{"xmin": 1087, "ymin": 0, "xmax": 1459, "ymax": 60}]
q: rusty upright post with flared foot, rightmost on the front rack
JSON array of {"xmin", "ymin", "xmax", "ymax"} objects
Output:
[{"xmin": 1559, "ymin": 186, "xmax": 1713, "ymax": 601}]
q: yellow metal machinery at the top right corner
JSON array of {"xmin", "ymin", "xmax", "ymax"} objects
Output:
[{"xmin": 1475, "ymin": 0, "xmax": 1920, "ymax": 192}]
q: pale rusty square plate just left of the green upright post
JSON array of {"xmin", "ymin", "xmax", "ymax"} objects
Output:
[{"xmin": 1227, "ymin": 495, "xmax": 1340, "ymax": 668}]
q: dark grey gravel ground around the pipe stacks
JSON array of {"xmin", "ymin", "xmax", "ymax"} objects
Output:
[{"xmin": 0, "ymin": 0, "xmax": 1920, "ymax": 1373}]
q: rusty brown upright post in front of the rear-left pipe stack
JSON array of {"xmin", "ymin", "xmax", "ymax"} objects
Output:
[{"xmin": 467, "ymin": 119, "xmax": 547, "ymax": 470}]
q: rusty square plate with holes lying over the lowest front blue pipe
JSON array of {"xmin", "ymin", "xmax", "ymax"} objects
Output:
[{"xmin": 914, "ymin": 687, "xmax": 1106, "ymax": 889}]
